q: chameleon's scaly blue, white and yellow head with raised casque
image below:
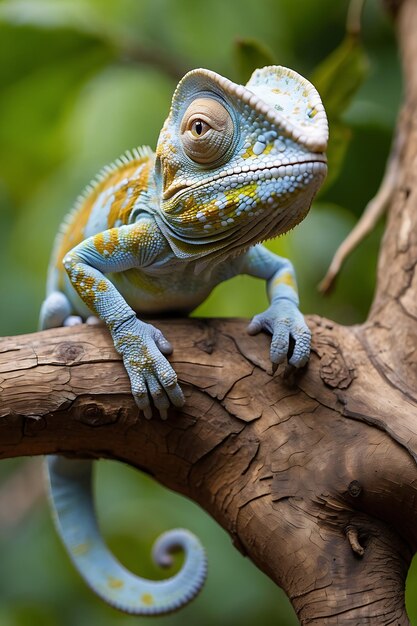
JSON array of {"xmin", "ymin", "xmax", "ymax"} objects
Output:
[{"xmin": 156, "ymin": 66, "xmax": 328, "ymax": 254}]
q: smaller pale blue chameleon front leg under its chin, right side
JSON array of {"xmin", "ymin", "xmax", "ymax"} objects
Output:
[{"xmin": 241, "ymin": 244, "xmax": 311, "ymax": 371}]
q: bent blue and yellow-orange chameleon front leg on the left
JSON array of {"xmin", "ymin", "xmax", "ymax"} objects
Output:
[{"xmin": 63, "ymin": 222, "xmax": 184, "ymax": 419}]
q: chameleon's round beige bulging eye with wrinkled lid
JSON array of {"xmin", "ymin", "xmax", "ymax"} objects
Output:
[{"xmin": 180, "ymin": 98, "xmax": 234, "ymax": 165}]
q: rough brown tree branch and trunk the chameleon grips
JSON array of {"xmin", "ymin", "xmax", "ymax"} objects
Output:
[{"xmin": 0, "ymin": 0, "xmax": 417, "ymax": 626}]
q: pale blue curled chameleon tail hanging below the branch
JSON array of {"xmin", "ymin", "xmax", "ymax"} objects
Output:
[{"xmin": 46, "ymin": 456, "xmax": 207, "ymax": 615}]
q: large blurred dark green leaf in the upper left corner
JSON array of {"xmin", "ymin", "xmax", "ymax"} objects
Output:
[{"xmin": 0, "ymin": 18, "xmax": 117, "ymax": 206}]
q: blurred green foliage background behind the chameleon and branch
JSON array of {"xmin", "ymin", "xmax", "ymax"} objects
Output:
[{"xmin": 0, "ymin": 0, "xmax": 417, "ymax": 626}]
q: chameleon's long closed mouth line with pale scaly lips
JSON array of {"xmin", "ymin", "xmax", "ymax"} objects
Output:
[{"xmin": 164, "ymin": 153, "xmax": 327, "ymax": 200}]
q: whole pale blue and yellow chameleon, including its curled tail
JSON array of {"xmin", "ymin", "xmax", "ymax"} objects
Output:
[{"xmin": 40, "ymin": 66, "xmax": 328, "ymax": 614}]
